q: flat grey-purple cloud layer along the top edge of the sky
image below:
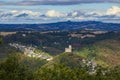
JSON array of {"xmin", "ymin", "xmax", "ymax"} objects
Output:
[{"xmin": 0, "ymin": 0, "xmax": 120, "ymax": 5}]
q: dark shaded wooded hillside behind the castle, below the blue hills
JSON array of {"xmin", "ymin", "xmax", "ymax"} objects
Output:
[{"xmin": 0, "ymin": 30, "xmax": 120, "ymax": 56}]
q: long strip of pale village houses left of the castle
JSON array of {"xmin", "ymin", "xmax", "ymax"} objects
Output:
[{"xmin": 9, "ymin": 43, "xmax": 53, "ymax": 61}]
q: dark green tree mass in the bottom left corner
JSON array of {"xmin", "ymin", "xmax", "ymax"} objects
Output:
[{"xmin": 0, "ymin": 54, "xmax": 33, "ymax": 80}]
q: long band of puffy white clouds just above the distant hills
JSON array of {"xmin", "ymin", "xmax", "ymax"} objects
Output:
[{"xmin": 0, "ymin": 6, "xmax": 120, "ymax": 23}]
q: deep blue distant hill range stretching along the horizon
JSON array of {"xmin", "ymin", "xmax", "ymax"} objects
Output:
[{"xmin": 0, "ymin": 21, "xmax": 120, "ymax": 31}]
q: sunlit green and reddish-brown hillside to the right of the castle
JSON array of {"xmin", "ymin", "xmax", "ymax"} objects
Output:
[{"xmin": 74, "ymin": 39, "xmax": 120, "ymax": 67}]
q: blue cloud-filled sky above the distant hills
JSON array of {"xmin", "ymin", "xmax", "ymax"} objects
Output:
[{"xmin": 0, "ymin": 0, "xmax": 120, "ymax": 24}]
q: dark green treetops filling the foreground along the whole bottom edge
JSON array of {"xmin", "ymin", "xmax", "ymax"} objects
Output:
[{"xmin": 0, "ymin": 54, "xmax": 120, "ymax": 80}]
